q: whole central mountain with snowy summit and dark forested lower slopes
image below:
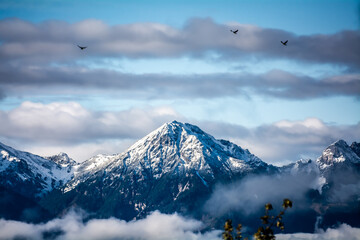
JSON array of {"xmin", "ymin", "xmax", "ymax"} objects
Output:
[{"xmin": 40, "ymin": 121, "xmax": 276, "ymax": 220}]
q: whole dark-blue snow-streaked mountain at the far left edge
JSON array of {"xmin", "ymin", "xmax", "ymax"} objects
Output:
[{"xmin": 0, "ymin": 143, "xmax": 72, "ymax": 222}]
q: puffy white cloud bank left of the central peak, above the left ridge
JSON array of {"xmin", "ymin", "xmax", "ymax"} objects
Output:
[{"xmin": 0, "ymin": 102, "xmax": 182, "ymax": 162}]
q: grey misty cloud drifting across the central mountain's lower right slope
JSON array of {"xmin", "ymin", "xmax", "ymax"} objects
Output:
[{"xmin": 205, "ymin": 171, "xmax": 321, "ymax": 217}]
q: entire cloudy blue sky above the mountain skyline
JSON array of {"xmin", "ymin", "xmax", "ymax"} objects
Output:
[{"xmin": 0, "ymin": 0, "xmax": 360, "ymax": 165}]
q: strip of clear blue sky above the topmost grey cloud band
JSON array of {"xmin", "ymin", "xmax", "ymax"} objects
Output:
[{"xmin": 0, "ymin": 0, "xmax": 359, "ymax": 34}]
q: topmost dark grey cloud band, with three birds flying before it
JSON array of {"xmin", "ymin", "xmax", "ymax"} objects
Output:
[{"xmin": 0, "ymin": 18, "xmax": 360, "ymax": 67}]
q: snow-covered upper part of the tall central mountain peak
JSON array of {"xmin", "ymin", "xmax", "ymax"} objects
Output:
[{"xmin": 124, "ymin": 121, "xmax": 266, "ymax": 177}]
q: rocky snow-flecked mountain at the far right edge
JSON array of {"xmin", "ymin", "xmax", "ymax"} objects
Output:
[{"xmin": 316, "ymin": 140, "xmax": 360, "ymax": 227}]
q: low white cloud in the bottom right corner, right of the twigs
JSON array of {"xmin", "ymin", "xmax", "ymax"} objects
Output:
[{"xmin": 276, "ymin": 224, "xmax": 360, "ymax": 240}]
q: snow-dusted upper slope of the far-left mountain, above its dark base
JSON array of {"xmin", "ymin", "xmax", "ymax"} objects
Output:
[{"xmin": 0, "ymin": 143, "xmax": 73, "ymax": 197}]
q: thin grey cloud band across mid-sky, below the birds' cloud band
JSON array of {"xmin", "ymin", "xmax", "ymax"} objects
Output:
[{"xmin": 0, "ymin": 63, "xmax": 360, "ymax": 99}]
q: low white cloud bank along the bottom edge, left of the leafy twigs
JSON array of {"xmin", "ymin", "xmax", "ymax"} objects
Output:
[{"xmin": 0, "ymin": 211, "xmax": 220, "ymax": 240}]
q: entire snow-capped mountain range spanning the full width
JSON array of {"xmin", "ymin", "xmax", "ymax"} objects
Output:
[{"xmin": 0, "ymin": 121, "xmax": 360, "ymax": 231}]
